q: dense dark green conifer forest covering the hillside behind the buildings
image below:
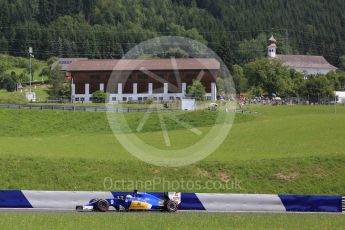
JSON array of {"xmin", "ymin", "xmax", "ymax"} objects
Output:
[{"xmin": 0, "ymin": 0, "xmax": 345, "ymax": 66}]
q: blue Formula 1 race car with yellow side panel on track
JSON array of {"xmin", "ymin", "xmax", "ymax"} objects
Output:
[{"xmin": 76, "ymin": 191, "xmax": 181, "ymax": 212}]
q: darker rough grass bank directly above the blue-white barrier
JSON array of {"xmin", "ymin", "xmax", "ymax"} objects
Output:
[{"xmin": 0, "ymin": 155, "xmax": 345, "ymax": 195}]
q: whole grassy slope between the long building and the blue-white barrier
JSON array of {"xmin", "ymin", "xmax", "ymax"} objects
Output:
[{"xmin": 0, "ymin": 106, "xmax": 345, "ymax": 194}]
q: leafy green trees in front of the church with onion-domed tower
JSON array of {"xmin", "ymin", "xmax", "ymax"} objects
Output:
[{"xmin": 223, "ymin": 57, "xmax": 345, "ymax": 102}]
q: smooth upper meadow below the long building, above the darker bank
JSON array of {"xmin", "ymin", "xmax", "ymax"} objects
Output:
[{"xmin": 0, "ymin": 106, "xmax": 345, "ymax": 161}]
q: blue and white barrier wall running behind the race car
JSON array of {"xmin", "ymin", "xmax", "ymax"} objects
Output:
[{"xmin": 0, "ymin": 190, "xmax": 345, "ymax": 212}]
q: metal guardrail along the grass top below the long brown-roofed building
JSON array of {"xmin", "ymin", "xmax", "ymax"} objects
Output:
[{"xmin": 0, "ymin": 104, "xmax": 161, "ymax": 113}]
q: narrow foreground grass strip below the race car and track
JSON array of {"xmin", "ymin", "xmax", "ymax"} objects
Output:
[{"xmin": 0, "ymin": 213, "xmax": 345, "ymax": 230}]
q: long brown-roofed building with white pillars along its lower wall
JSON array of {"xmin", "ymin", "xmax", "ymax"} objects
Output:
[{"xmin": 67, "ymin": 59, "xmax": 220, "ymax": 103}]
